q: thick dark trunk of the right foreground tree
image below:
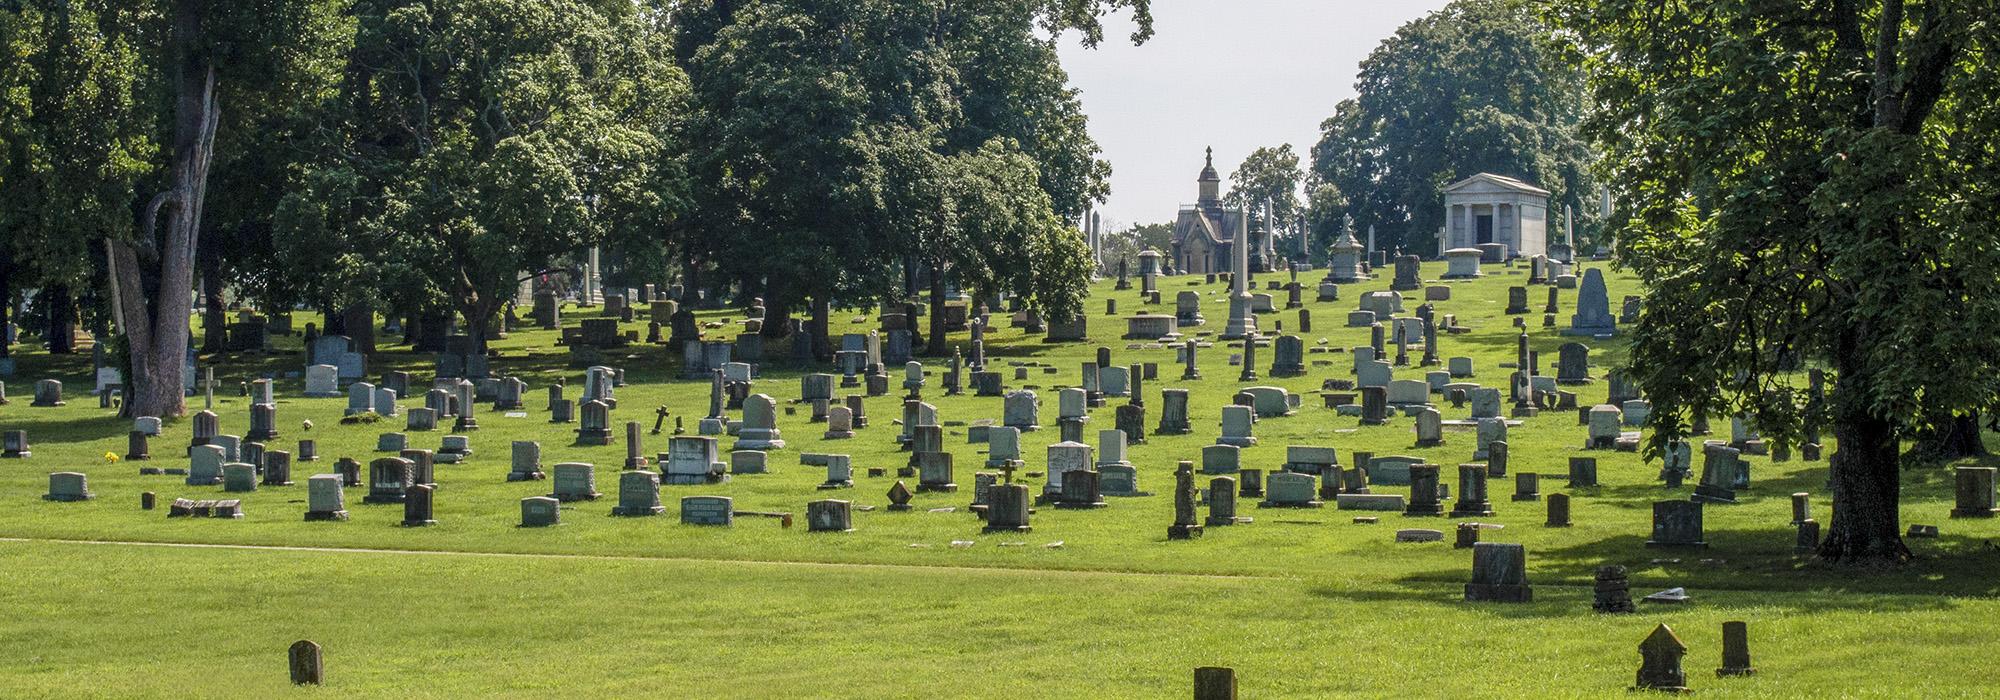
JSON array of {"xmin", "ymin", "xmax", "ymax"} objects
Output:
[{"xmin": 1820, "ymin": 328, "xmax": 1910, "ymax": 564}]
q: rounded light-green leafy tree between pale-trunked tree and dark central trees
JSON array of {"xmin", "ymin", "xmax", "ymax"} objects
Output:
[{"xmin": 280, "ymin": 0, "xmax": 684, "ymax": 350}]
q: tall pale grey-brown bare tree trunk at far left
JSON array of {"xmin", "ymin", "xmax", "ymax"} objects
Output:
[{"xmin": 110, "ymin": 0, "xmax": 220, "ymax": 418}]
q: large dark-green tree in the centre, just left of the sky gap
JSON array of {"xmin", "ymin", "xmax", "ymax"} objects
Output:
[{"xmin": 674, "ymin": 0, "xmax": 1150, "ymax": 352}]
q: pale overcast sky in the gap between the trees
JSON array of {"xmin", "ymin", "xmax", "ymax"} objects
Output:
[{"xmin": 1062, "ymin": 0, "xmax": 1446, "ymax": 230}]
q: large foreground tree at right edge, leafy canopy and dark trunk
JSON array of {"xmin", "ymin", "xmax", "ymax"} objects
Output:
[{"xmin": 1554, "ymin": 0, "xmax": 2000, "ymax": 562}]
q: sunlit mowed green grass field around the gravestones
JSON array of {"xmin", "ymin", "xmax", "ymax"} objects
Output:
[{"xmin": 0, "ymin": 264, "xmax": 2000, "ymax": 696}]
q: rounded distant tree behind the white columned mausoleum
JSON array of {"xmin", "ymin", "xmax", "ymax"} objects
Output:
[{"xmin": 1312, "ymin": 0, "xmax": 1596, "ymax": 252}]
